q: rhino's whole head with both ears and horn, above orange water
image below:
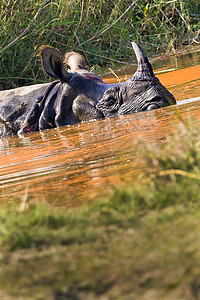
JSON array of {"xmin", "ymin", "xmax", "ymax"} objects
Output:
[{"xmin": 38, "ymin": 42, "xmax": 176, "ymax": 124}]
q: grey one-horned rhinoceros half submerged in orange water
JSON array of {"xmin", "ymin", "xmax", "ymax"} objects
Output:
[{"xmin": 0, "ymin": 42, "xmax": 176, "ymax": 136}]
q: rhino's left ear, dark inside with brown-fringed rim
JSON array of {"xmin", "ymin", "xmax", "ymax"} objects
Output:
[{"xmin": 40, "ymin": 46, "xmax": 71, "ymax": 82}]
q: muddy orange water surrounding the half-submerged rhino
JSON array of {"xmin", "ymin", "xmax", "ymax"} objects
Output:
[{"xmin": 0, "ymin": 52, "xmax": 200, "ymax": 206}]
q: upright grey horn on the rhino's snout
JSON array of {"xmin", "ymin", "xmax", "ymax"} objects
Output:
[{"xmin": 130, "ymin": 42, "xmax": 156, "ymax": 81}]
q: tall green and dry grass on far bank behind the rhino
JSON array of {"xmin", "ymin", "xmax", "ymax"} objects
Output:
[{"xmin": 0, "ymin": 0, "xmax": 200, "ymax": 89}]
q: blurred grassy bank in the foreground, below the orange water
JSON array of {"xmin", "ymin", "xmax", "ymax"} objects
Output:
[{"xmin": 0, "ymin": 129, "xmax": 200, "ymax": 300}]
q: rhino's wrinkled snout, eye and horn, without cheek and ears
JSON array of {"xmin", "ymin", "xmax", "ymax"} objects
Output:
[{"xmin": 97, "ymin": 42, "xmax": 176, "ymax": 117}]
